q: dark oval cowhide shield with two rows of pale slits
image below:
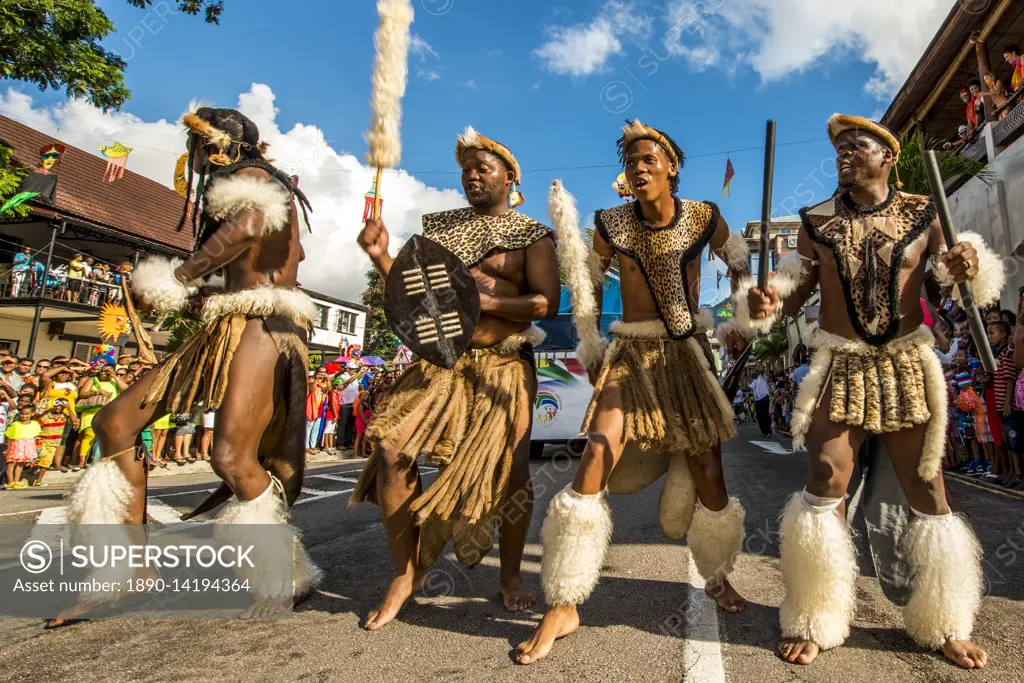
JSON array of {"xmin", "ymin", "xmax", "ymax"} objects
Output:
[{"xmin": 384, "ymin": 234, "xmax": 480, "ymax": 370}]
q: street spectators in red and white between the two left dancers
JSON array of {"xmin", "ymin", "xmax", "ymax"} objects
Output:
[{"xmin": 306, "ymin": 360, "xmax": 402, "ymax": 458}]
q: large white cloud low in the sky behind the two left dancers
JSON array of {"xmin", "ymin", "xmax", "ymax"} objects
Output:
[{"xmin": 0, "ymin": 84, "xmax": 466, "ymax": 301}]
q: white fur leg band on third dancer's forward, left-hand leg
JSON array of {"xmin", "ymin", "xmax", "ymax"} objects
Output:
[{"xmin": 541, "ymin": 486, "xmax": 611, "ymax": 605}]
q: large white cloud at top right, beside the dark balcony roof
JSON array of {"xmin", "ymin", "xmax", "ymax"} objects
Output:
[{"xmin": 663, "ymin": 0, "xmax": 952, "ymax": 99}]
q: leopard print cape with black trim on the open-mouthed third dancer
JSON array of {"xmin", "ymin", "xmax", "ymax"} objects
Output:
[{"xmin": 594, "ymin": 199, "xmax": 719, "ymax": 339}]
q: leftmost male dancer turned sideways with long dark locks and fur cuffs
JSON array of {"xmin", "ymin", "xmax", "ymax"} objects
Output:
[{"xmin": 51, "ymin": 108, "xmax": 321, "ymax": 626}]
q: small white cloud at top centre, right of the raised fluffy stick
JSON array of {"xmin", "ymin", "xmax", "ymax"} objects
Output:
[{"xmin": 534, "ymin": 0, "xmax": 652, "ymax": 76}]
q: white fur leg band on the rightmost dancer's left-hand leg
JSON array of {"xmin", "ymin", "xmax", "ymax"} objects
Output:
[{"xmin": 779, "ymin": 494, "xmax": 857, "ymax": 650}]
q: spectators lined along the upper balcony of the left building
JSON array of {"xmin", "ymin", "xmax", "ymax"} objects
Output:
[{"xmin": 0, "ymin": 247, "xmax": 132, "ymax": 306}]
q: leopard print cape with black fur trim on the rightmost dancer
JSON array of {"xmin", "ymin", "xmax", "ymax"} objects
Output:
[{"xmin": 800, "ymin": 186, "xmax": 936, "ymax": 346}]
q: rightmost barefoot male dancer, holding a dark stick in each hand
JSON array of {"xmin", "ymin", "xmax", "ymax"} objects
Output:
[{"xmin": 736, "ymin": 114, "xmax": 1005, "ymax": 669}]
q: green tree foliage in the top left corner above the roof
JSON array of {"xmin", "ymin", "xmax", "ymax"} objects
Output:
[{"xmin": 0, "ymin": 0, "xmax": 223, "ymax": 111}]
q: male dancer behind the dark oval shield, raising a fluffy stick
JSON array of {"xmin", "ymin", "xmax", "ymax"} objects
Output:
[{"xmin": 351, "ymin": 128, "xmax": 560, "ymax": 631}]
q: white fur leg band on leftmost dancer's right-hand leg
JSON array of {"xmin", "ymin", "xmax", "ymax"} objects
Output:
[{"xmin": 214, "ymin": 477, "xmax": 324, "ymax": 599}]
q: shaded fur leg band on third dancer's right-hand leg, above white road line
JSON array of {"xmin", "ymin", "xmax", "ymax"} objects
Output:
[{"xmin": 686, "ymin": 498, "xmax": 745, "ymax": 585}]
